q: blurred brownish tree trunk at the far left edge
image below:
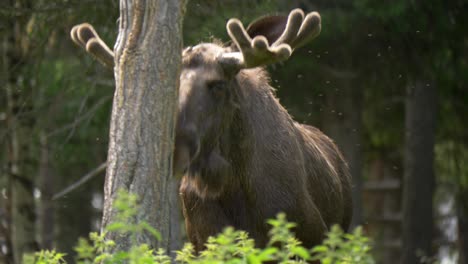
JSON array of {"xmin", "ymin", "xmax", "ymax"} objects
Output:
[{"xmin": 3, "ymin": 0, "xmax": 38, "ymax": 263}]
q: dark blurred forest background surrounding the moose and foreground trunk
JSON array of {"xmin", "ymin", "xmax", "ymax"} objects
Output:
[{"xmin": 0, "ymin": 0, "xmax": 468, "ymax": 263}]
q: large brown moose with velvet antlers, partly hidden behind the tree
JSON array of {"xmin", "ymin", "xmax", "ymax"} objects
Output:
[{"xmin": 71, "ymin": 9, "xmax": 352, "ymax": 251}]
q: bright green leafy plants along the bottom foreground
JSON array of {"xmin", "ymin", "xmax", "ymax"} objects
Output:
[{"xmin": 25, "ymin": 191, "xmax": 374, "ymax": 264}]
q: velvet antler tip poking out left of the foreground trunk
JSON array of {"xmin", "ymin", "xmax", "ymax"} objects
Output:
[{"xmin": 70, "ymin": 23, "xmax": 114, "ymax": 69}]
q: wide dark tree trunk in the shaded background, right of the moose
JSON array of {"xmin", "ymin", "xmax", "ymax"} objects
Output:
[{"xmin": 401, "ymin": 81, "xmax": 436, "ymax": 264}]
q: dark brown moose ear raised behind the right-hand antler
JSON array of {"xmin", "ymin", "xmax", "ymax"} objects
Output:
[{"xmin": 247, "ymin": 16, "xmax": 288, "ymax": 45}]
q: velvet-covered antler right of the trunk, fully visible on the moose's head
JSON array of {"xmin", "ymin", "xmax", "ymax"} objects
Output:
[{"xmin": 218, "ymin": 9, "xmax": 321, "ymax": 69}]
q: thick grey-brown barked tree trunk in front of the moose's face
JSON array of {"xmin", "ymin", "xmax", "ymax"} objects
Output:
[{"xmin": 102, "ymin": 0, "xmax": 186, "ymax": 253}]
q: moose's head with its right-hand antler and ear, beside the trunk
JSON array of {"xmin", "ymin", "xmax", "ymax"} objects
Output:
[{"xmin": 175, "ymin": 9, "xmax": 320, "ymax": 177}]
